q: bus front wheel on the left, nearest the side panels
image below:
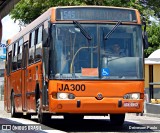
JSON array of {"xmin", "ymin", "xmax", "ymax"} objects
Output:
[{"xmin": 36, "ymin": 98, "xmax": 51, "ymax": 124}]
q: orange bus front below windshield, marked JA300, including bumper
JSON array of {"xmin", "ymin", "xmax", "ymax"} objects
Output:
[{"xmin": 49, "ymin": 81, "xmax": 144, "ymax": 114}]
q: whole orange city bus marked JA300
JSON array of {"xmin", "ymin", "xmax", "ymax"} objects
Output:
[{"xmin": 4, "ymin": 6, "xmax": 148, "ymax": 125}]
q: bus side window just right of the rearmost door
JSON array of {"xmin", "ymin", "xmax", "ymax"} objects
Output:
[{"xmin": 12, "ymin": 42, "xmax": 18, "ymax": 71}]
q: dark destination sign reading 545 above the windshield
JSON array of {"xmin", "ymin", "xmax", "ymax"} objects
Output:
[{"xmin": 56, "ymin": 7, "xmax": 136, "ymax": 22}]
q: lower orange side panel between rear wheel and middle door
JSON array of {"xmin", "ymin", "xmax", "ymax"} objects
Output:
[{"xmin": 11, "ymin": 69, "xmax": 22, "ymax": 112}]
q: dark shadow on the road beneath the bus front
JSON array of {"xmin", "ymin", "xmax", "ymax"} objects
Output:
[{"xmin": 39, "ymin": 119, "xmax": 153, "ymax": 132}]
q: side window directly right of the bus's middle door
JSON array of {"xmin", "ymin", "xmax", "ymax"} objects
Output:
[{"xmin": 28, "ymin": 31, "xmax": 35, "ymax": 64}]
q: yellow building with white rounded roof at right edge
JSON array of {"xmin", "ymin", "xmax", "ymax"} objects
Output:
[{"xmin": 145, "ymin": 49, "xmax": 160, "ymax": 115}]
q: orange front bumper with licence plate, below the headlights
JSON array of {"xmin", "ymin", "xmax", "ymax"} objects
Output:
[{"xmin": 49, "ymin": 97, "xmax": 144, "ymax": 114}]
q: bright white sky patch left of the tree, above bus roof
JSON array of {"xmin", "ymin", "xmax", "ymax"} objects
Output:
[{"xmin": 2, "ymin": 15, "xmax": 20, "ymax": 44}]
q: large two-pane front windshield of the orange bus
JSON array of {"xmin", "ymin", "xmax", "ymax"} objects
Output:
[{"xmin": 49, "ymin": 23, "xmax": 143, "ymax": 80}]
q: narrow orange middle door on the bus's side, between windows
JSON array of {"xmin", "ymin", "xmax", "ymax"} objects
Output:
[{"xmin": 22, "ymin": 42, "xmax": 28, "ymax": 111}]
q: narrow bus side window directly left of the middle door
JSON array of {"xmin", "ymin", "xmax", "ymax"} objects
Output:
[{"xmin": 18, "ymin": 39, "xmax": 23, "ymax": 69}]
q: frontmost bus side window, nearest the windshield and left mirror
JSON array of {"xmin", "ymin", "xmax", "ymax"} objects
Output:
[{"xmin": 35, "ymin": 26, "xmax": 43, "ymax": 61}]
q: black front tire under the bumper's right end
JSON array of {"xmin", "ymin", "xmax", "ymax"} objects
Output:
[{"xmin": 110, "ymin": 114, "xmax": 125, "ymax": 126}]
